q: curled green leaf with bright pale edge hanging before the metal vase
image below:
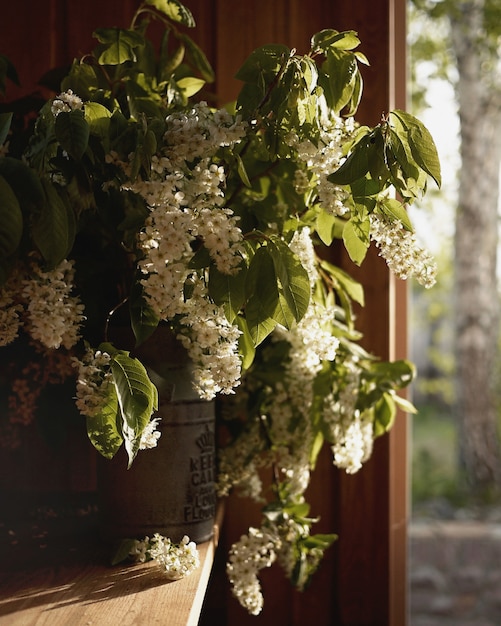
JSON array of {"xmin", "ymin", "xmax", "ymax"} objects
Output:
[{"xmin": 111, "ymin": 351, "xmax": 158, "ymax": 467}]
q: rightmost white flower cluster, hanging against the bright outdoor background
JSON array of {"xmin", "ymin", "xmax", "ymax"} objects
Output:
[{"xmin": 370, "ymin": 213, "xmax": 437, "ymax": 288}]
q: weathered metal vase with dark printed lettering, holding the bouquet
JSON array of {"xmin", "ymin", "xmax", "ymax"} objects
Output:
[{"xmin": 98, "ymin": 329, "xmax": 216, "ymax": 543}]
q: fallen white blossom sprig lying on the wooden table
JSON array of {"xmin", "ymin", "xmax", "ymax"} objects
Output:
[{"xmin": 129, "ymin": 533, "xmax": 200, "ymax": 580}]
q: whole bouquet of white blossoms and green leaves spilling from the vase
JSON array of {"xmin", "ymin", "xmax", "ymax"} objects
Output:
[{"xmin": 0, "ymin": 0, "xmax": 440, "ymax": 614}]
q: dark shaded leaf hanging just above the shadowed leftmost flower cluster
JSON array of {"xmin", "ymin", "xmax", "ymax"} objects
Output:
[{"xmin": 32, "ymin": 178, "xmax": 75, "ymax": 268}]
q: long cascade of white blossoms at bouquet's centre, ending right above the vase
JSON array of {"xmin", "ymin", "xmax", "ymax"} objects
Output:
[{"xmin": 125, "ymin": 103, "xmax": 245, "ymax": 399}]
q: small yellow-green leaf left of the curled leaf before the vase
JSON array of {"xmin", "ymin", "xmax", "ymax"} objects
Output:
[{"xmin": 86, "ymin": 385, "xmax": 123, "ymax": 459}]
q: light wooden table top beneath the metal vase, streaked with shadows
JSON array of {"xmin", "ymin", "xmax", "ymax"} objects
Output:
[{"xmin": 0, "ymin": 497, "xmax": 222, "ymax": 626}]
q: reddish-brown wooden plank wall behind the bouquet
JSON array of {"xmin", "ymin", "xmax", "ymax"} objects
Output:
[{"xmin": 0, "ymin": 0, "xmax": 407, "ymax": 626}]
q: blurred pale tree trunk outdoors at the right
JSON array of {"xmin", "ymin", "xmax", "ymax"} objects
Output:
[{"xmin": 450, "ymin": 0, "xmax": 501, "ymax": 491}]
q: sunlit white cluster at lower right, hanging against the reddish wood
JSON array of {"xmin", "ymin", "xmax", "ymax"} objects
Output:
[{"xmin": 323, "ymin": 360, "xmax": 374, "ymax": 474}]
